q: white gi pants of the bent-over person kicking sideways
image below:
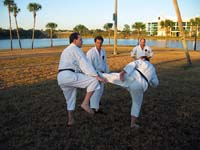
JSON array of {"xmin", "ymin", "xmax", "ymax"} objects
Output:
[{"xmin": 103, "ymin": 73, "xmax": 146, "ymax": 117}]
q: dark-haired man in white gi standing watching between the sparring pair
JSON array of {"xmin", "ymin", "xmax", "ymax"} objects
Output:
[{"xmin": 87, "ymin": 36, "xmax": 109, "ymax": 113}]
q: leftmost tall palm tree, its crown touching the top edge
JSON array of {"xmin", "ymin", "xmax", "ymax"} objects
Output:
[{"xmin": 3, "ymin": 0, "xmax": 14, "ymax": 50}]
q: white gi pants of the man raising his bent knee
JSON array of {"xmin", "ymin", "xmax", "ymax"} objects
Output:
[{"xmin": 57, "ymin": 70, "xmax": 100, "ymax": 110}]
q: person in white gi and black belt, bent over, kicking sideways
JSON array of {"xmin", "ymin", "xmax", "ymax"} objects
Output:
[{"xmin": 103, "ymin": 54, "xmax": 159, "ymax": 128}]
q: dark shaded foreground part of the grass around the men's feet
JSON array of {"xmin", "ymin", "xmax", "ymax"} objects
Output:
[{"xmin": 0, "ymin": 62, "xmax": 200, "ymax": 150}]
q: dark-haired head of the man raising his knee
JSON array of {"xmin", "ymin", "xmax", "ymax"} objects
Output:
[{"xmin": 69, "ymin": 32, "xmax": 83, "ymax": 47}]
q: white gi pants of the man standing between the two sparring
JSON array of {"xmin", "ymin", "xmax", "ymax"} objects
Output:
[{"xmin": 90, "ymin": 83, "xmax": 104, "ymax": 109}]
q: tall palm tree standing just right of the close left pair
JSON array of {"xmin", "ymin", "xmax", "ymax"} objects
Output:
[{"xmin": 27, "ymin": 3, "xmax": 42, "ymax": 49}]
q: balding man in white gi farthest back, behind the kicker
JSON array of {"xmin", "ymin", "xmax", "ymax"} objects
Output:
[{"xmin": 131, "ymin": 38, "xmax": 153, "ymax": 60}]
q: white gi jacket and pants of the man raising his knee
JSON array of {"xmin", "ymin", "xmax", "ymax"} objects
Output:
[{"xmin": 57, "ymin": 43, "xmax": 100, "ymax": 110}]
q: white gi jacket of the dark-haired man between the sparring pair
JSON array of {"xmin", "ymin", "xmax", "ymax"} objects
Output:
[{"xmin": 87, "ymin": 47, "xmax": 109, "ymax": 74}]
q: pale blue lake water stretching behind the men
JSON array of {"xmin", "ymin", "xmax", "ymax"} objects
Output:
[{"xmin": 0, "ymin": 38, "xmax": 200, "ymax": 50}]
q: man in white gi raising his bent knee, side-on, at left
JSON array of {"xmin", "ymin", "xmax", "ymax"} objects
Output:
[{"xmin": 57, "ymin": 32, "xmax": 105, "ymax": 126}]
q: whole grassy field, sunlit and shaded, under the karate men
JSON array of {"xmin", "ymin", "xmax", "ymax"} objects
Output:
[{"xmin": 0, "ymin": 46, "xmax": 200, "ymax": 150}]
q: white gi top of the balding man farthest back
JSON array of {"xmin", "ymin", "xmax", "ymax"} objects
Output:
[{"xmin": 131, "ymin": 45, "xmax": 153, "ymax": 59}]
